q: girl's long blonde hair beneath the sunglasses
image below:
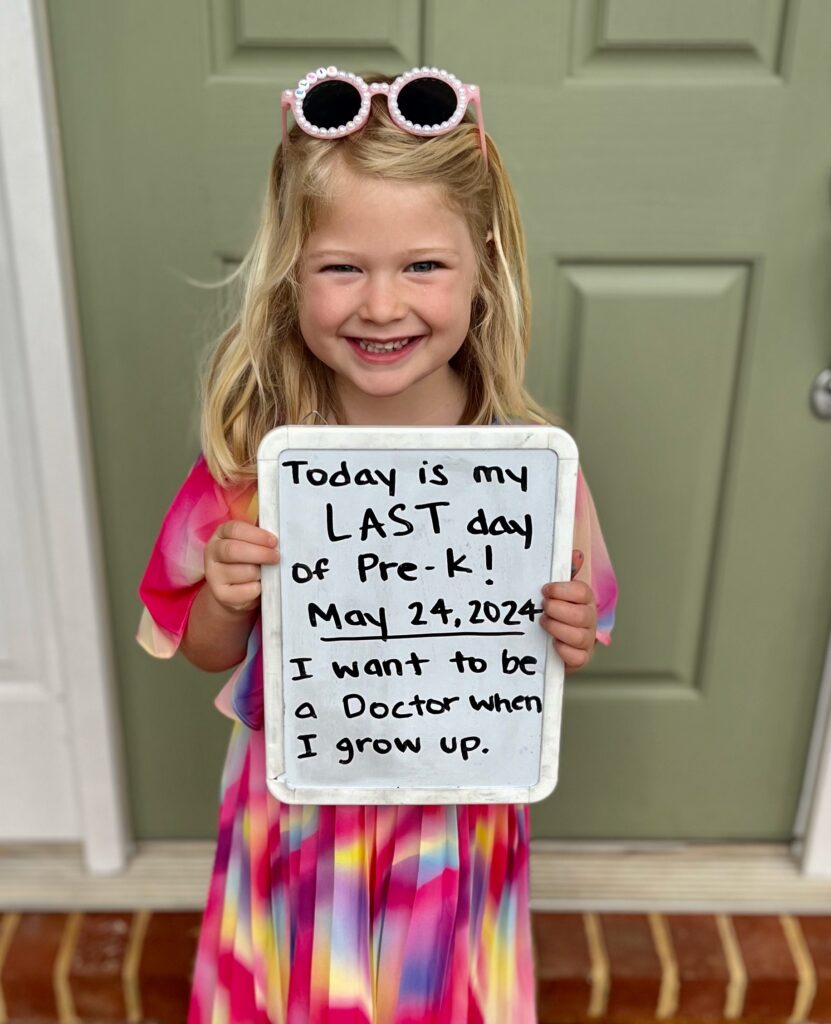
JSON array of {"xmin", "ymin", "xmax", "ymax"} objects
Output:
[{"xmin": 201, "ymin": 75, "xmax": 557, "ymax": 482}]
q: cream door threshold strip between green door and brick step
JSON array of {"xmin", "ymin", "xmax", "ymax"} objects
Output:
[{"xmin": 0, "ymin": 840, "xmax": 831, "ymax": 913}]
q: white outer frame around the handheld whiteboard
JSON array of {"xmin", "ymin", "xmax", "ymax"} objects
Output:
[{"xmin": 257, "ymin": 425, "xmax": 578, "ymax": 804}]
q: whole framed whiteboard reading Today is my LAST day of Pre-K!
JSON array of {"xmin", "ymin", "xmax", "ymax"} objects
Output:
[{"xmin": 258, "ymin": 426, "xmax": 577, "ymax": 804}]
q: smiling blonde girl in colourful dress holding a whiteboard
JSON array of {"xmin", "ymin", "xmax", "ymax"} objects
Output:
[{"xmin": 138, "ymin": 69, "xmax": 617, "ymax": 1024}]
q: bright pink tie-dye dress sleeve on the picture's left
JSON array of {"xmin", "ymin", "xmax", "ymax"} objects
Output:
[{"xmin": 136, "ymin": 455, "xmax": 256, "ymax": 657}]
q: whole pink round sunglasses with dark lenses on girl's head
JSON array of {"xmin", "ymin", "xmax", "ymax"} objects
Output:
[{"xmin": 281, "ymin": 67, "xmax": 487, "ymax": 167}]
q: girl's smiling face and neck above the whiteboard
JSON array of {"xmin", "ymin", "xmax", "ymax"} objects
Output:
[{"xmin": 299, "ymin": 167, "xmax": 476, "ymax": 425}]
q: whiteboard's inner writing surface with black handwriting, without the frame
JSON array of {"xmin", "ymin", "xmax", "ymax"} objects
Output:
[{"xmin": 278, "ymin": 442, "xmax": 565, "ymax": 791}]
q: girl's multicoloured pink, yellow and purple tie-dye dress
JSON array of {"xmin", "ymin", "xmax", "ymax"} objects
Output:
[{"xmin": 137, "ymin": 442, "xmax": 617, "ymax": 1024}]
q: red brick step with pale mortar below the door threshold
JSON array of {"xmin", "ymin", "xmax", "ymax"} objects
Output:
[{"xmin": 0, "ymin": 910, "xmax": 831, "ymax": 1024}]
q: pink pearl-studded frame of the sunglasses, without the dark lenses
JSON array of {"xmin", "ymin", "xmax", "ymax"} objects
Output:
[{"xmin": 280, "ymin": 67, "xmax": 487, "ymax": 167}]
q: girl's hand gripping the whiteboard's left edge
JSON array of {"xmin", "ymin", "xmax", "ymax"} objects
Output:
[{"xmin": 205, "ymin": 519, "xmax": 279, "ymax": 612}]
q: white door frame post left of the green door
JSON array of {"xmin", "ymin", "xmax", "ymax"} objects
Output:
[{"xmin": 0, "ymin": 0, "xmax": 131, "ymax": 873}]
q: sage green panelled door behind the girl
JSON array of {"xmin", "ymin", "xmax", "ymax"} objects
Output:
[{"xmin": 48, "ymin": 0, "xmax": 831, "ymax": 840}]
